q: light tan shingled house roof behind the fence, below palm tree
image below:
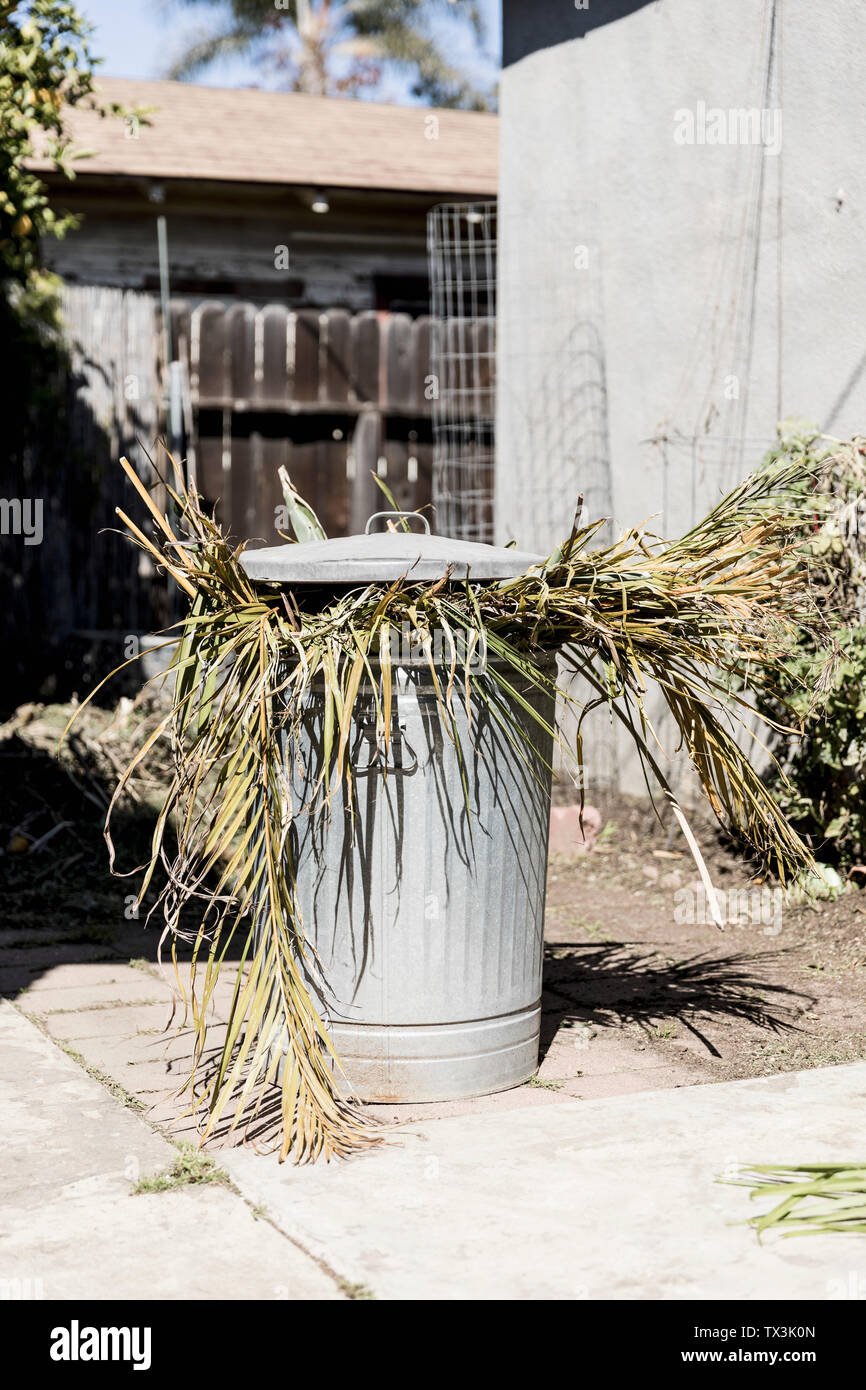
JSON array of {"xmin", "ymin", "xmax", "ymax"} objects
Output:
[{"xmin": 33, "ymin": 78, "xmax": 499, "ymax": 195}]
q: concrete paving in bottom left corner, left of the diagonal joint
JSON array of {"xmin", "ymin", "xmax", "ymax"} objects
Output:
[{"xmin": 0, "ymin": 1002, "xmax": 342, "ymax": 1301}]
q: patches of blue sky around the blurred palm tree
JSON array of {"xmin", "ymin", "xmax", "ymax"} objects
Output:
[{"xmin": 76, "ymin": 0, "xmax": 500, "ymax": 103}]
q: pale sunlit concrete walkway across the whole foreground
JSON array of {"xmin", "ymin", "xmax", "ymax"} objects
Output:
[{"xmin": 0, "ymin": 989, "xmax": 866, "ymax": 1300}]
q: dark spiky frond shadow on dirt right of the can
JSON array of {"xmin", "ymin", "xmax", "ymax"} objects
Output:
[{"xmin": 541, "ymin": 942, "xmax": 813, "ymax": 1056}]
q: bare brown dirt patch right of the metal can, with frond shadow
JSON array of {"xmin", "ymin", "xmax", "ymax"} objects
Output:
[{"xmin": 545, "ymin": 796, "xmax": 866, "ymax": 1080}]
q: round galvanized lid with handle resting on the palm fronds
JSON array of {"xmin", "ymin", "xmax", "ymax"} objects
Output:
[{"xmin": 240, "ymin": 512, "xmax": 545, "ymax": 584}]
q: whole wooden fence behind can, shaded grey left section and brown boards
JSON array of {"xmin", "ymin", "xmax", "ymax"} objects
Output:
[{"xmin": 0, "ymin": 294, "xmax": 492, "ymax": 706}]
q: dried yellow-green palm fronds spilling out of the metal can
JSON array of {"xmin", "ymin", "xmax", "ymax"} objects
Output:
[{"xmin": 71, "ymin": 444, "xmax": 839, "ymax": 1159}]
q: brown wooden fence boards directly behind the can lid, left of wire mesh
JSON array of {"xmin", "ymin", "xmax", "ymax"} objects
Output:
[{"xmin": 172, "ymin": 300, "xmax": 436, "ymax": 545}]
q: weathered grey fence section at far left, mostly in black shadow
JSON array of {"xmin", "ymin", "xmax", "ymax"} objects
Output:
[{"xmin": 0, "ymin": 286, "xmax": 172, "ymax": 705}]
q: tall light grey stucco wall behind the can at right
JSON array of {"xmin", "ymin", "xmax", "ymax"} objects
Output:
[{"xmin": 496, "ymin": 0, "xmax": 866, "ymax": 795}]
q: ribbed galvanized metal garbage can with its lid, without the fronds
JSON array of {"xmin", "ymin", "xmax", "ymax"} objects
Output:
[{"xmin": 243, "ymin": 513, "xmax": 555, "ymax": 1102}]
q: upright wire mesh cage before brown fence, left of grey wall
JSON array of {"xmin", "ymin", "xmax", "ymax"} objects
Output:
[{"xmin": 427, "ymin": 203, "xmax": 496, "ymax": 542}]
